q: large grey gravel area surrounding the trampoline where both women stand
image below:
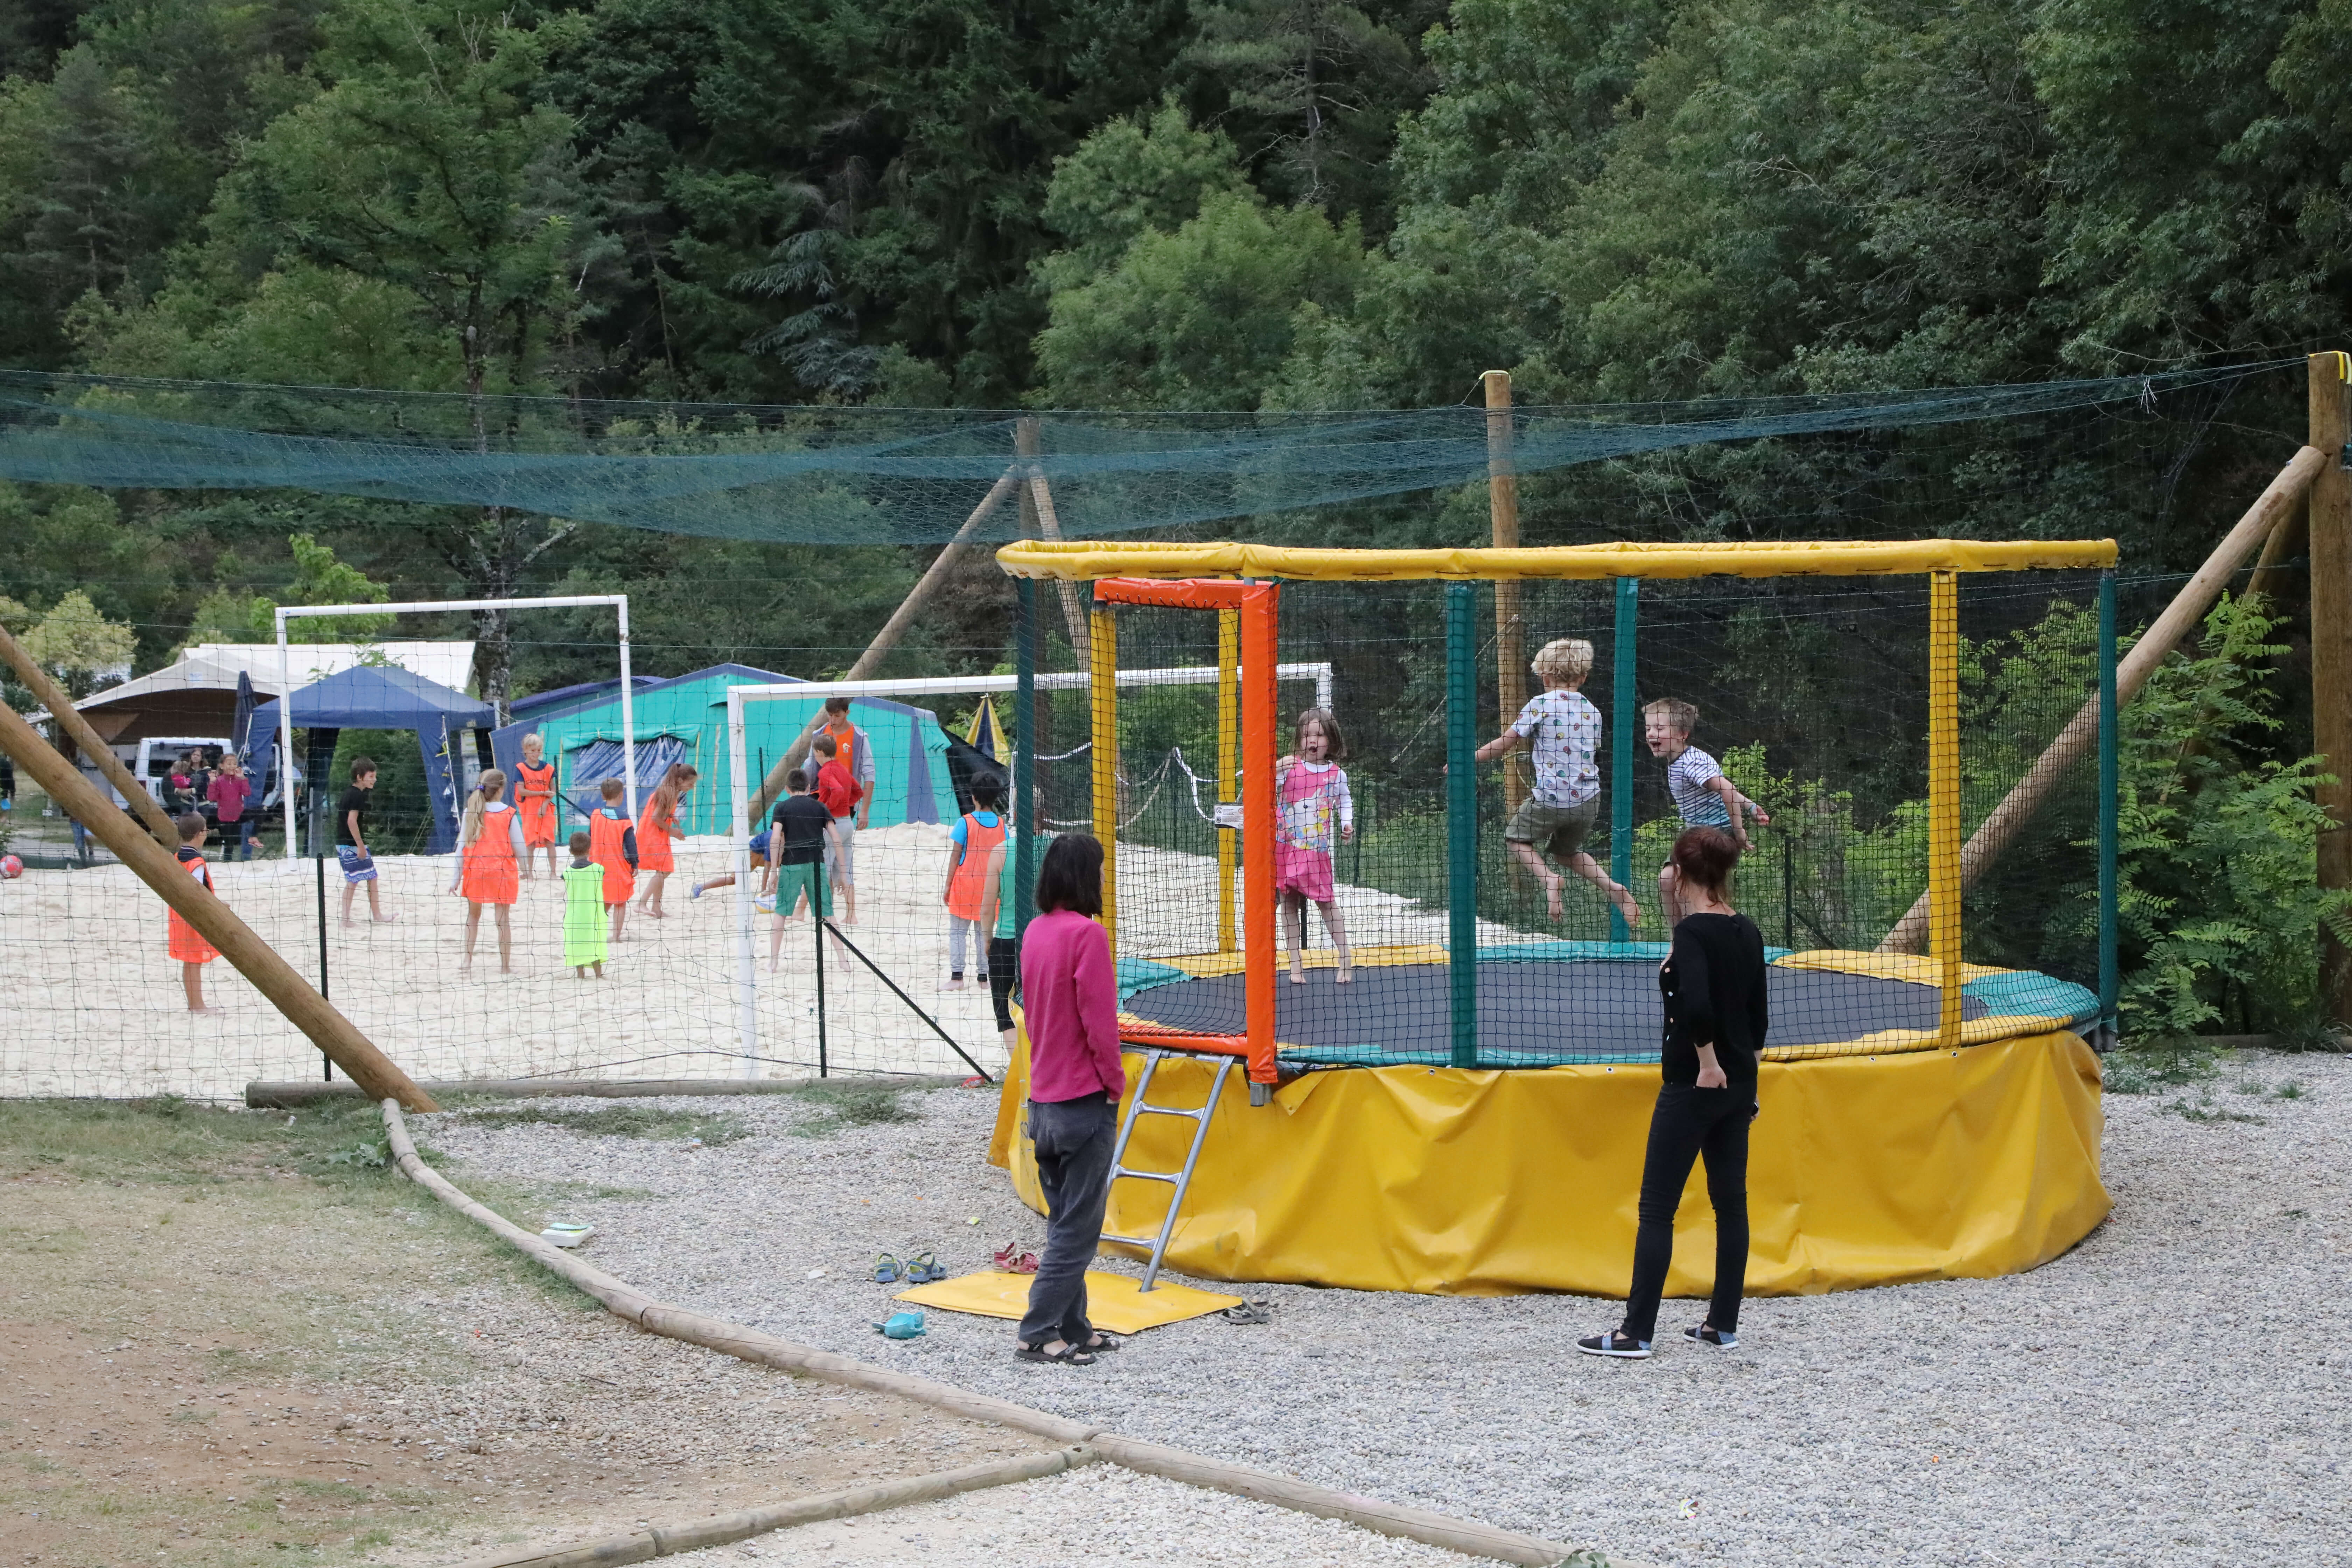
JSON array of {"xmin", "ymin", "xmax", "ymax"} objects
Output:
[{"xmin": 416, "ymin": 1053, "xmax": 2352, "ymax": 1568}]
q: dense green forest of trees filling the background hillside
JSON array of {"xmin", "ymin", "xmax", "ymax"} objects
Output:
[{"xmin": 0, "ymin": 0, "xmax": 2352, "ymax": 1029}]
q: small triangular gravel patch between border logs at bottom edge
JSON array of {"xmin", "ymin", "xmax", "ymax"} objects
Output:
[{"xmin": 663, "ymin": 1464, "xmax": 1470, "ymax": 1568}]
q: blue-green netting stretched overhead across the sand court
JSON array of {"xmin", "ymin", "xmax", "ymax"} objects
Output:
[{"xmin": 0, "ymin": 360, "xmax": 2303, "ymax": 543}]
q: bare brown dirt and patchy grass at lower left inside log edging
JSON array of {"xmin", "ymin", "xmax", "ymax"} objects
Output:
[{"xmin": 0, "ymin": 1105, "xmax": 1042, "ymax": 1568}]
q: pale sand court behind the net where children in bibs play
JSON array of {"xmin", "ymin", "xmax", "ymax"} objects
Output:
[{"xmin": 0, "ymin": 823, "xmax": 1510, "ymax": 1100}]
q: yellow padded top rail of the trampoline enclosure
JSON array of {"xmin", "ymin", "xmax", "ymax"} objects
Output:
[{"xmin": 997, "ymin": 538, "xmax": 2117, "ymax": 583}]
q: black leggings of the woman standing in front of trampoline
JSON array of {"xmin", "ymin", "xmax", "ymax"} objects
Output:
[{"xmin": 1618, "ymin": 1084, "xmax": 1757, "ymax": 1342}]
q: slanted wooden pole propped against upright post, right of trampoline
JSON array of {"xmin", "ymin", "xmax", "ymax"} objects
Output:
[{"xmin": 1879, "ymin": 447, "xmax": 2329, "ymax": 952}]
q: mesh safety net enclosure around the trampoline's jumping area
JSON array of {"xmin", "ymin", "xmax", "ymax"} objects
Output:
[{"xmin": 1030, "ymin": 545, "xmax": 2100, "ymax": 1067}]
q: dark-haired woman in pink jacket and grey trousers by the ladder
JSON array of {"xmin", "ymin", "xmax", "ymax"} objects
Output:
[{"xmin": 1016, "ymin": 832, "xmax": 1127, "ymax": 1366}]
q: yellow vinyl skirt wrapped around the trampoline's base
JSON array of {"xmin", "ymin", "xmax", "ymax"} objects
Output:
[{"xmin": 990, "ymin": 1030, "xmax": 2110, "ymax": 1295}]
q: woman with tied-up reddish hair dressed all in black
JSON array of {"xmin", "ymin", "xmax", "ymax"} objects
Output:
[{"xmin": 1576, "ymin": 827, "xmax": 1766, "ymax": 1361}]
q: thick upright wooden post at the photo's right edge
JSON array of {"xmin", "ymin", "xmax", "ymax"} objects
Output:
[{"xmin": 2307, "ymin": 352, "xmax": 2352, "ymax": 1025}]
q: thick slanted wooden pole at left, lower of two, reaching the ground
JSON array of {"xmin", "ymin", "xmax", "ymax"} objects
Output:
[{"xmin": 0, "ymin": 703, "xmax": 440, "ymax": 1110}]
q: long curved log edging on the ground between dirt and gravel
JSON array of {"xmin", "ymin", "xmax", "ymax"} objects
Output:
[{"xmin": 383, "ymin": 1100, "xmax": 1646, "ymax": 1568}]
